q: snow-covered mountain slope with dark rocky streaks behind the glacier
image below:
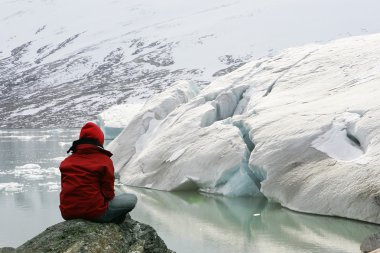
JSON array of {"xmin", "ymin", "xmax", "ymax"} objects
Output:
[{"xmin": 0, "ymin": 0, "xmax": 380, "ymax": 127}]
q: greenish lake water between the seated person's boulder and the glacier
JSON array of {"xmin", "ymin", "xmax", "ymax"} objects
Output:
[{"xmin": 124, "ymin": 187, "xmax": 380, "ymax": 253}]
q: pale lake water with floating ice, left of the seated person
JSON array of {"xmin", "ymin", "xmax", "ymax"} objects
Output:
[{"xmin": 0, "ymin": 129, "xmax": 74, "ymax": 247}]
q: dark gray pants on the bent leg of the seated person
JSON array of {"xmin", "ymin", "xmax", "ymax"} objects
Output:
[{"xmin": 94, "ymin": 193, "xmax": 137, "ymax": 224}]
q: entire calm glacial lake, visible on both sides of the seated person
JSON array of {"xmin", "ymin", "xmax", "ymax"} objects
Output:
[{"xmin": 0, "ymin": 129, "xmax": 380, "ymax": 253}]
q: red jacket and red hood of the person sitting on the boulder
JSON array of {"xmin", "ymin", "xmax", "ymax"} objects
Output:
[{"xmin": 59, "ymin": 123, "xmax": 115, "ymax": 220}]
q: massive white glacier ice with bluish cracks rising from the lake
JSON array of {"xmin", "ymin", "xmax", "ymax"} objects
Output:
[{"xmin": 108, "ymin": 34, "xmax": 380, "ymax": 223}]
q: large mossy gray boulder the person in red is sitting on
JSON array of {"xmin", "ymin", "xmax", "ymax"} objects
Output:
[{"xmin": 0, "ymin": 217, "xmax": 173, "ymax": 253}]
